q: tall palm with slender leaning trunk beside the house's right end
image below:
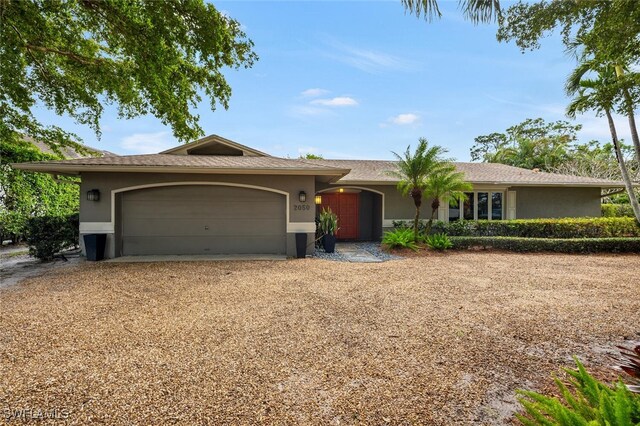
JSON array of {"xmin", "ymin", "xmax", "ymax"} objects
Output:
[{"xmin": 565, "ymin": 63, "xmax": 640, "ymax": 224}]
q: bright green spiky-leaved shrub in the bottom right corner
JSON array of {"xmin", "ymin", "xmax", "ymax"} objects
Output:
[{"xmin": 516, "ymin": 359, "xmax": 640, "ymax": 426}]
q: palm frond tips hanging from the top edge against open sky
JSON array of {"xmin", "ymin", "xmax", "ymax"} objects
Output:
[{"xmin": 401, "ymin": 0, "xmax": 500, "ymax": 24}]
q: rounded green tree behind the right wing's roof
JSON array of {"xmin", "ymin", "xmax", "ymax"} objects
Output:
[{"xmin": 471, "ymin": 118, "xmax": 581, "ymax": 171}]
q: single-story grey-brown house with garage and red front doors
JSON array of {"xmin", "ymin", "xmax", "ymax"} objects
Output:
[{"xmin": 13, "ymin": 135, "xmax": 621, "ymax": 258}]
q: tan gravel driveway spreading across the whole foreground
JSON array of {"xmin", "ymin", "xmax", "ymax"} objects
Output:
[{"xmin": 0, "ymin": 252, "xmax": 640, "ymax": 425}]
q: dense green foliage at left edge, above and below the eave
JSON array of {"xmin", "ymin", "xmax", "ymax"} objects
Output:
[{"xmin": 0, "ymin": 140, "xmax": 79, "ymax": 240}]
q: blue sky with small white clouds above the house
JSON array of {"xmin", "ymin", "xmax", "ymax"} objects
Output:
[{"xmin": 31, "ymin": 0, "xmax": 627, "ymax": 161}]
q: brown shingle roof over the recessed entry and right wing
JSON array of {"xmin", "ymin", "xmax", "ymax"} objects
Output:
[{"xmin": 305, "ymin": 160, "xmax": 624, "ymax": 187}]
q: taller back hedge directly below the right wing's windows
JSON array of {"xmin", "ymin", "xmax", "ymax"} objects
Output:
[{"xmin": 432, "ymin": 217, "xmax": 640, "ymax": 238}]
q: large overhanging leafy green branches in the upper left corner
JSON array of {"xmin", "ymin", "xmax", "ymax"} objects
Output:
[{"xmin": 0, "ymin": 0, "xmax": 257, "ymax": 150}]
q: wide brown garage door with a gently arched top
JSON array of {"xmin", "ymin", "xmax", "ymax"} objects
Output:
[{"xmin": 120, "ymin": 185, "xmax": 286, "ymax": 256}]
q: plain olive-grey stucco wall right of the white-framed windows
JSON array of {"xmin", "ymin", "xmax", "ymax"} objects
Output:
[{"xmin": 509, "ymin": 187, "xmax": 601, "ymax": 219}]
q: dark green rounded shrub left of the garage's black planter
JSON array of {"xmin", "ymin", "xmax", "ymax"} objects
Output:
[{"xmin": 26, "ymin": 214, "xmax": 79, "ymax": 260}]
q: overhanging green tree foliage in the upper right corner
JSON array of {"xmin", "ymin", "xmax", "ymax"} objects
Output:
[{"xmin": 497, "ymin": 0, "xmax": 640, "ymax": 162}]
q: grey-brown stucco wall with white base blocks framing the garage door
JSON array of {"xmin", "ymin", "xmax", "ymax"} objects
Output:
[{"xmin": 80, "ymin": 173, "xmax": 315, "ymax": 257}]
